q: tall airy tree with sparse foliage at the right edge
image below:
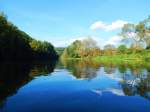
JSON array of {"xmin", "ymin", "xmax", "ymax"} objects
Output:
[{"xmin": 120, "ymin": 17, "xmax": 150, "ymax": 50}]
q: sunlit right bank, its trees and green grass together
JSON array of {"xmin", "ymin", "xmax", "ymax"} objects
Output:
[{"xmin": 61, "ymin": 17, "xmax": 150, "ymax": 63}]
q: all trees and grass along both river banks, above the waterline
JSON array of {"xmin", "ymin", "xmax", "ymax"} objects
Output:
[{"xmin": 0, "ymin": 13, "xmax": 150, "ymax": 63}]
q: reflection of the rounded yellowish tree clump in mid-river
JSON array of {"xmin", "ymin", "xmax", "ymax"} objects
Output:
[{"xmin": 61, "ymin": 60, "xmax": 100, "ymax": 80}]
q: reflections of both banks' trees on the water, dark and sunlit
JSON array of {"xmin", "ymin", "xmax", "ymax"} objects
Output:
[{"xmin": 0, "ymin": 60, "xmax": 150, "ymax": 109}]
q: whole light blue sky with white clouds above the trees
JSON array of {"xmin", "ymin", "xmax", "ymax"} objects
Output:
[{"xmin": 0, "ymin": 0, "xmax": 150, "ymax": 47}]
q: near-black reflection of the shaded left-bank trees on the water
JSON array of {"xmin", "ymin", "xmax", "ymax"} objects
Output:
[{"xmin": 0, "ymin": 61, "xmax": 56, "ymax": 107}]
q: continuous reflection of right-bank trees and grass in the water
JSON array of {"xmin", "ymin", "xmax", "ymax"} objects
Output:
[{"xmin": 61, "ymin": 60, "xmax": 150, "ymax": 99}]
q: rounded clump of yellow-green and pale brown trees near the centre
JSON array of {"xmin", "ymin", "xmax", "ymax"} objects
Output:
[{"xmin": 62, "ymin": 38, "xmax": 100, "ymax": 58}]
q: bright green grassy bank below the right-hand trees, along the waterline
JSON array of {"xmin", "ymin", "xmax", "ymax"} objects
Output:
[{"xmin": 62, "ymin": 51, "xmax": 150, "ymax": 63}]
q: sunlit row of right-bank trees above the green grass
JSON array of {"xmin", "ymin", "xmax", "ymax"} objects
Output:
[{"xmin": 62, "ymin": 16, "xmax": 150, "ymax": 58}]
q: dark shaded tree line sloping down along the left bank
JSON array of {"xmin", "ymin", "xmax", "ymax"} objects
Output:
[{"xmin": 0, "ymin": 13, "xmax": 58, "ymax": 60}]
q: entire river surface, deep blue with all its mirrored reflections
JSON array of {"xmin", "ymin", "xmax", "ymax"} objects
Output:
[{"xmin": 0, "ymin": 60, "xmax": 150, "ymax": 112}]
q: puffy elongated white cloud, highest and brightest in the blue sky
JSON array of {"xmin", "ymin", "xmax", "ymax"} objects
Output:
[{"xmin": 90, "ymin": 20, "xmax": 128, "ymax": 31}]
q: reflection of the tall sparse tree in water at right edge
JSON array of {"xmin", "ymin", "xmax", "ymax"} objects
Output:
[{"xmin": 121, "ymin": 68, "xmax": 150, "ymax": 99}]
